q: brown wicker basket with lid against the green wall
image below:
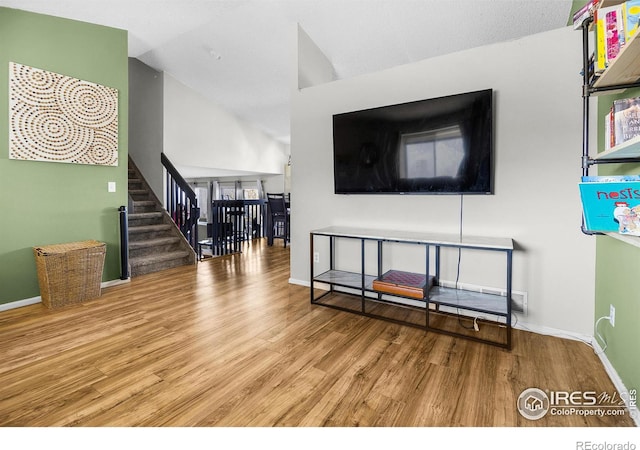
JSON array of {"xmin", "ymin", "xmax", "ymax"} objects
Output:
[{"xmin": 33, "ymin": 241, "xmax": 106, "ymax": 308}]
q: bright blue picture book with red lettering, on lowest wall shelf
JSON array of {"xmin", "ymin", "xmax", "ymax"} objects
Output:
[{"xmin": 580, "ymin": 175, "xmax": 640, "ymax": 236}]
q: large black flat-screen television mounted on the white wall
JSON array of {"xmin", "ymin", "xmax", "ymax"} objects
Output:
[{"xmin": 333, "ymin": 89, "xmax": 494, "ymax": 194}]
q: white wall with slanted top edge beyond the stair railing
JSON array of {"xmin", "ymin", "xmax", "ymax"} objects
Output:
[{"xmin": 164, "ymin": 74, "xmax": 289, "ymax": 174}]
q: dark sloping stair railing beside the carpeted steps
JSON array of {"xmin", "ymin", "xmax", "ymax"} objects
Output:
[{"xmin": 160, "ymin": 153, "xmax": 200, "ymax": 252}]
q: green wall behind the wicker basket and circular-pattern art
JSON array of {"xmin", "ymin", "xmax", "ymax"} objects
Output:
[{"xmin": 0, "ymin": 8, "xmax": 129, "ymax": 304}]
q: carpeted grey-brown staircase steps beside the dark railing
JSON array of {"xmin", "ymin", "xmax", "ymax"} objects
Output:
[{"xmin": 128, "ymin": 158, "xmax": 197, "ymax": 277}]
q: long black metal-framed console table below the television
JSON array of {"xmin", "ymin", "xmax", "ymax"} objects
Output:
[{"xmin": 309, "ymin": 226, "xmax": 513, "ymax": 349}]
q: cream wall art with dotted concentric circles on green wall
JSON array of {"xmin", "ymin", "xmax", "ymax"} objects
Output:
[{"xmin": 9, "ymin": 62, "xmax": 118, "ymax": 166}]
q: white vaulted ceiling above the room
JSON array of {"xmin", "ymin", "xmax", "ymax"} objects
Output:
[{"xmin": 0, "ymin": 0, "xmax": 572, "ymax": 142}]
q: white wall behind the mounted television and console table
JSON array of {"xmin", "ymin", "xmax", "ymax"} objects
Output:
[{"xmin": 291, "ymin": 23, "xmax": 595, "ymax": 335}]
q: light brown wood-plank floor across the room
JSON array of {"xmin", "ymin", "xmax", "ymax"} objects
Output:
[{"xmin": 0, "ymin": 241, "xmax": 633, "ymax": 427}]
